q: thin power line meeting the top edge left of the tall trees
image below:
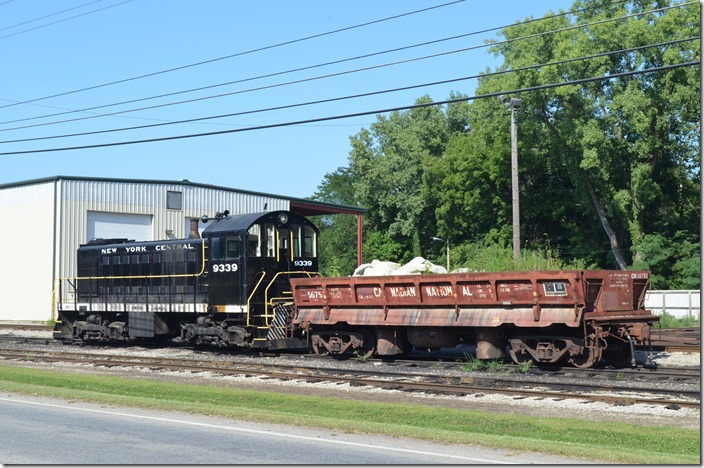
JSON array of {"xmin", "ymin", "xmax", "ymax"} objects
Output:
[{"xmin": 0, "ymin": 0, "xmax": 465, "ymax": 109}]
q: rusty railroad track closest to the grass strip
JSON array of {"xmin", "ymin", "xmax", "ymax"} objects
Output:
[{"xmin": 0, "ymin": 349, "xmax": 700, "ymax": 408}]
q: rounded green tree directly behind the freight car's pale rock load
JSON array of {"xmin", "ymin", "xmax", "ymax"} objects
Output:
[{"xmin": 349, "ymin": 96, "xmax": 452, "ymax": 262}]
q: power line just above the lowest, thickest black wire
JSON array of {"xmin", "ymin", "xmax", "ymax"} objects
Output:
[{"xmin": 0, "ymin": 36, "xmax": 699, "ymax": 144}]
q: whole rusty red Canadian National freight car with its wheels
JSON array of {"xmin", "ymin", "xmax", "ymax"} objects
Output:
[{"xmin": 291, "ymin": 270, "xmax": 659, "ymax": 367}]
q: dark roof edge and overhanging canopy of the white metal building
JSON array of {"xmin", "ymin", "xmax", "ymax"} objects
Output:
[{"xmin": 0, "ymin": 175, "xmax": 366, "ymax": 216}]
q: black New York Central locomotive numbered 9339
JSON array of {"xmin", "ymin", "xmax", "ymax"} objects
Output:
[{"xmin": 54, "ymin": 211, "xmax": 319, "ymax": 349}]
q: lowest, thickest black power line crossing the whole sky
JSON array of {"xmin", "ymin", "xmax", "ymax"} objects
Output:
[{"xmin": 0, "ymin": 61, "xmax": 700, "ymax": 156}]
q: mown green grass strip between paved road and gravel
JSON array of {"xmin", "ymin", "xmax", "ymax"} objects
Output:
[{"xmin": 0, "ymin": 366, "xmax": 701, "ymax": 464}]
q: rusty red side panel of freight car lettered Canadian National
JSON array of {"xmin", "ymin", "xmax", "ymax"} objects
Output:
[{"xmin": 292, "ymin": 271, "xmax": 603, "ymax": 327}]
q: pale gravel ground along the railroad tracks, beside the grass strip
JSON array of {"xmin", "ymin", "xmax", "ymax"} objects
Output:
[{"xmin": 0, "ymin": 329, "xmax": 701, "ymax": 429}]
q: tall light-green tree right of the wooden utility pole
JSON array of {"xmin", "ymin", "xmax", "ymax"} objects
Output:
[{"xmin": 472, "ymin": 0, "xmax": 700, "ymax": 282}]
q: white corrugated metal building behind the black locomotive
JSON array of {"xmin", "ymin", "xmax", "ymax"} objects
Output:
[{"xmin": 0, "ymin": 176, "xmax": 363, "ymax": 322}]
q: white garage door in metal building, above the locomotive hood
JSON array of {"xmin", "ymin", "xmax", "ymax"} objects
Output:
[{"xmin": 87, "ymin": 211, "xmax": 152, "ymax": 241}]
